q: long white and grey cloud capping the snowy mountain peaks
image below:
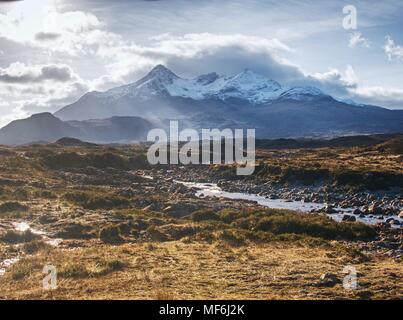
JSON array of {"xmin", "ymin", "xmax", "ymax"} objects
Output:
[{"xmin": 97, "ymin": 33, "xmax": 297, "ymax": 81}]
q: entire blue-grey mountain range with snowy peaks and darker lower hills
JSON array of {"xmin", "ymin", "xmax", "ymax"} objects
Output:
[{"xmin": 0, "ymin": 65, "xmax": 403, "ymax": 144}]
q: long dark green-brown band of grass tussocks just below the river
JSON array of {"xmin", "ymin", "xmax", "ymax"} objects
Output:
[{"xmin": 100, "ymin": 209, "xmax": 376, "ymax": 246}]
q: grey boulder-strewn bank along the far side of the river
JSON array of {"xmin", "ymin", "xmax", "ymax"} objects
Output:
[{"xmin": 147, "ymin": 167, "xmax": 403, "ymax": 227}]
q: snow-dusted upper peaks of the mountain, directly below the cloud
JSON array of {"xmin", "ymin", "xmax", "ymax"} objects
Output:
[{"xmin": 90, "ymin": 65, "xmax": 304, "ymax": 104}]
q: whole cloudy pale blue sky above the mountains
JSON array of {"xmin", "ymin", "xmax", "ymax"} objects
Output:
[{"xmin": 0, "ymin": 0, "xmax": 403, "ymax": 126}]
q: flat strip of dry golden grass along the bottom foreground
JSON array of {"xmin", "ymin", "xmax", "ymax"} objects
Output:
[{"xmin": 0, "ymin": 242, "xmax": 403, "ymax": 300}]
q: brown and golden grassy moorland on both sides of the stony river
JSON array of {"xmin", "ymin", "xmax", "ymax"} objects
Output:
[{"xmin": 0, "ymin": 138, "xmax": 403, "ymax": 299}]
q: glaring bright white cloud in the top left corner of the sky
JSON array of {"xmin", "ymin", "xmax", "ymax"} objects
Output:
[{"xmin": 0, "ymin": 0, "xmax": 109, "ymax": 55}]
